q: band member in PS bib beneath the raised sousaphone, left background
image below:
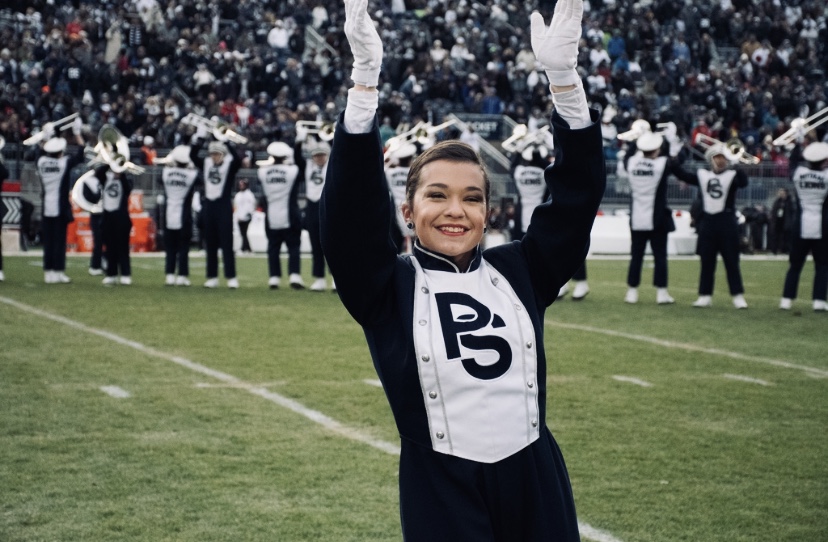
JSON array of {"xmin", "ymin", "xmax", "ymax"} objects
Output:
[{"xmin": 95, "ymin": 165, "xmax": 132, "ymax": 286}]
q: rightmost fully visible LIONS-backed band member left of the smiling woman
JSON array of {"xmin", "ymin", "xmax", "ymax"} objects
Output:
[{"xmin": 256, "ymin": 141, "xmax": 305, "ymax": 290}]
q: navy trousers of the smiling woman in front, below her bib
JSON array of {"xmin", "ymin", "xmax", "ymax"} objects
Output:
[{"xmin": 400, "ymin": 429, "xmax": 580, "ymax": 542}]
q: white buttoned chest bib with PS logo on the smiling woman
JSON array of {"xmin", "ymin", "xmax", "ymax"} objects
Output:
[{"xmin": 412, "ymin": 258, "xmax": 540, "ymax": 463}]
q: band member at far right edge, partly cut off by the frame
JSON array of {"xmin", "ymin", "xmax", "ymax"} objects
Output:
[{"xmin": 779, "ymin": 142, "xmax": 828, "ymax": 311}]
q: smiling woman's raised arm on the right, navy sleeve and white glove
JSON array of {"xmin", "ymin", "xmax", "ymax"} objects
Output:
[{"xmin": 522, "ymin": 0, "xmax": 606, "ymax": 304}]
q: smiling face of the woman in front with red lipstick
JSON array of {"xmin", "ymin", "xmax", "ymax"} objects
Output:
[{"xmin": 402, "ymin": 160, "xmax": 488, "ymax": 270}]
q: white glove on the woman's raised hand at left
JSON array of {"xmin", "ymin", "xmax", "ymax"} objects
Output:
[{"xmin": 344, "ymin": 0, "xmax": 382, "ymax": 87}]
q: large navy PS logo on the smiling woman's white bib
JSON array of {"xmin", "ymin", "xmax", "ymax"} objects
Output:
[{"xmin": 435, "ymin": 292, "xmax": 512, "ymax": 380}]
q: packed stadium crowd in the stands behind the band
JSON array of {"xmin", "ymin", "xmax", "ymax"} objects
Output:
[{"xmin": 0, "ymin": 0, "xmax": 828, "ymax": 160}]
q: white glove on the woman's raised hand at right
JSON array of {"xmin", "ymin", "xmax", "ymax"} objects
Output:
[{"xmin": 529, "ymin": 0, "xmax": 584, "ymax": 86}]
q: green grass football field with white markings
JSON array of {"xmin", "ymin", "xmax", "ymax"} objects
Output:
[{"xmin": 0, "ymin": 255, "xmax": 828, "ymax": 542}]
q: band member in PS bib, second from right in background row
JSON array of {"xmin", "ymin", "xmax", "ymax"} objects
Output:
[{"xmin": 674, "ymin": 143, "xmax": 748, "ymax": 309}]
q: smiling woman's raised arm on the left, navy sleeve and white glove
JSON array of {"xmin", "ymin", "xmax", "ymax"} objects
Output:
[{"xmin": 320, "ymin": 0, "xmax": 396, "ymax": 323}]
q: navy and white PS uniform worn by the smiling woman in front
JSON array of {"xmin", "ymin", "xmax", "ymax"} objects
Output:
[{"xmin": 321, "ymin": 100, "xmax": 606, "ymax": 542}]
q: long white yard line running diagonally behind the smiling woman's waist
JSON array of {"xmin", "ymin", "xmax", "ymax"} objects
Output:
[{"xmin": 0, "ymin": 296, "xmax": 621, "ymax": 542}]
